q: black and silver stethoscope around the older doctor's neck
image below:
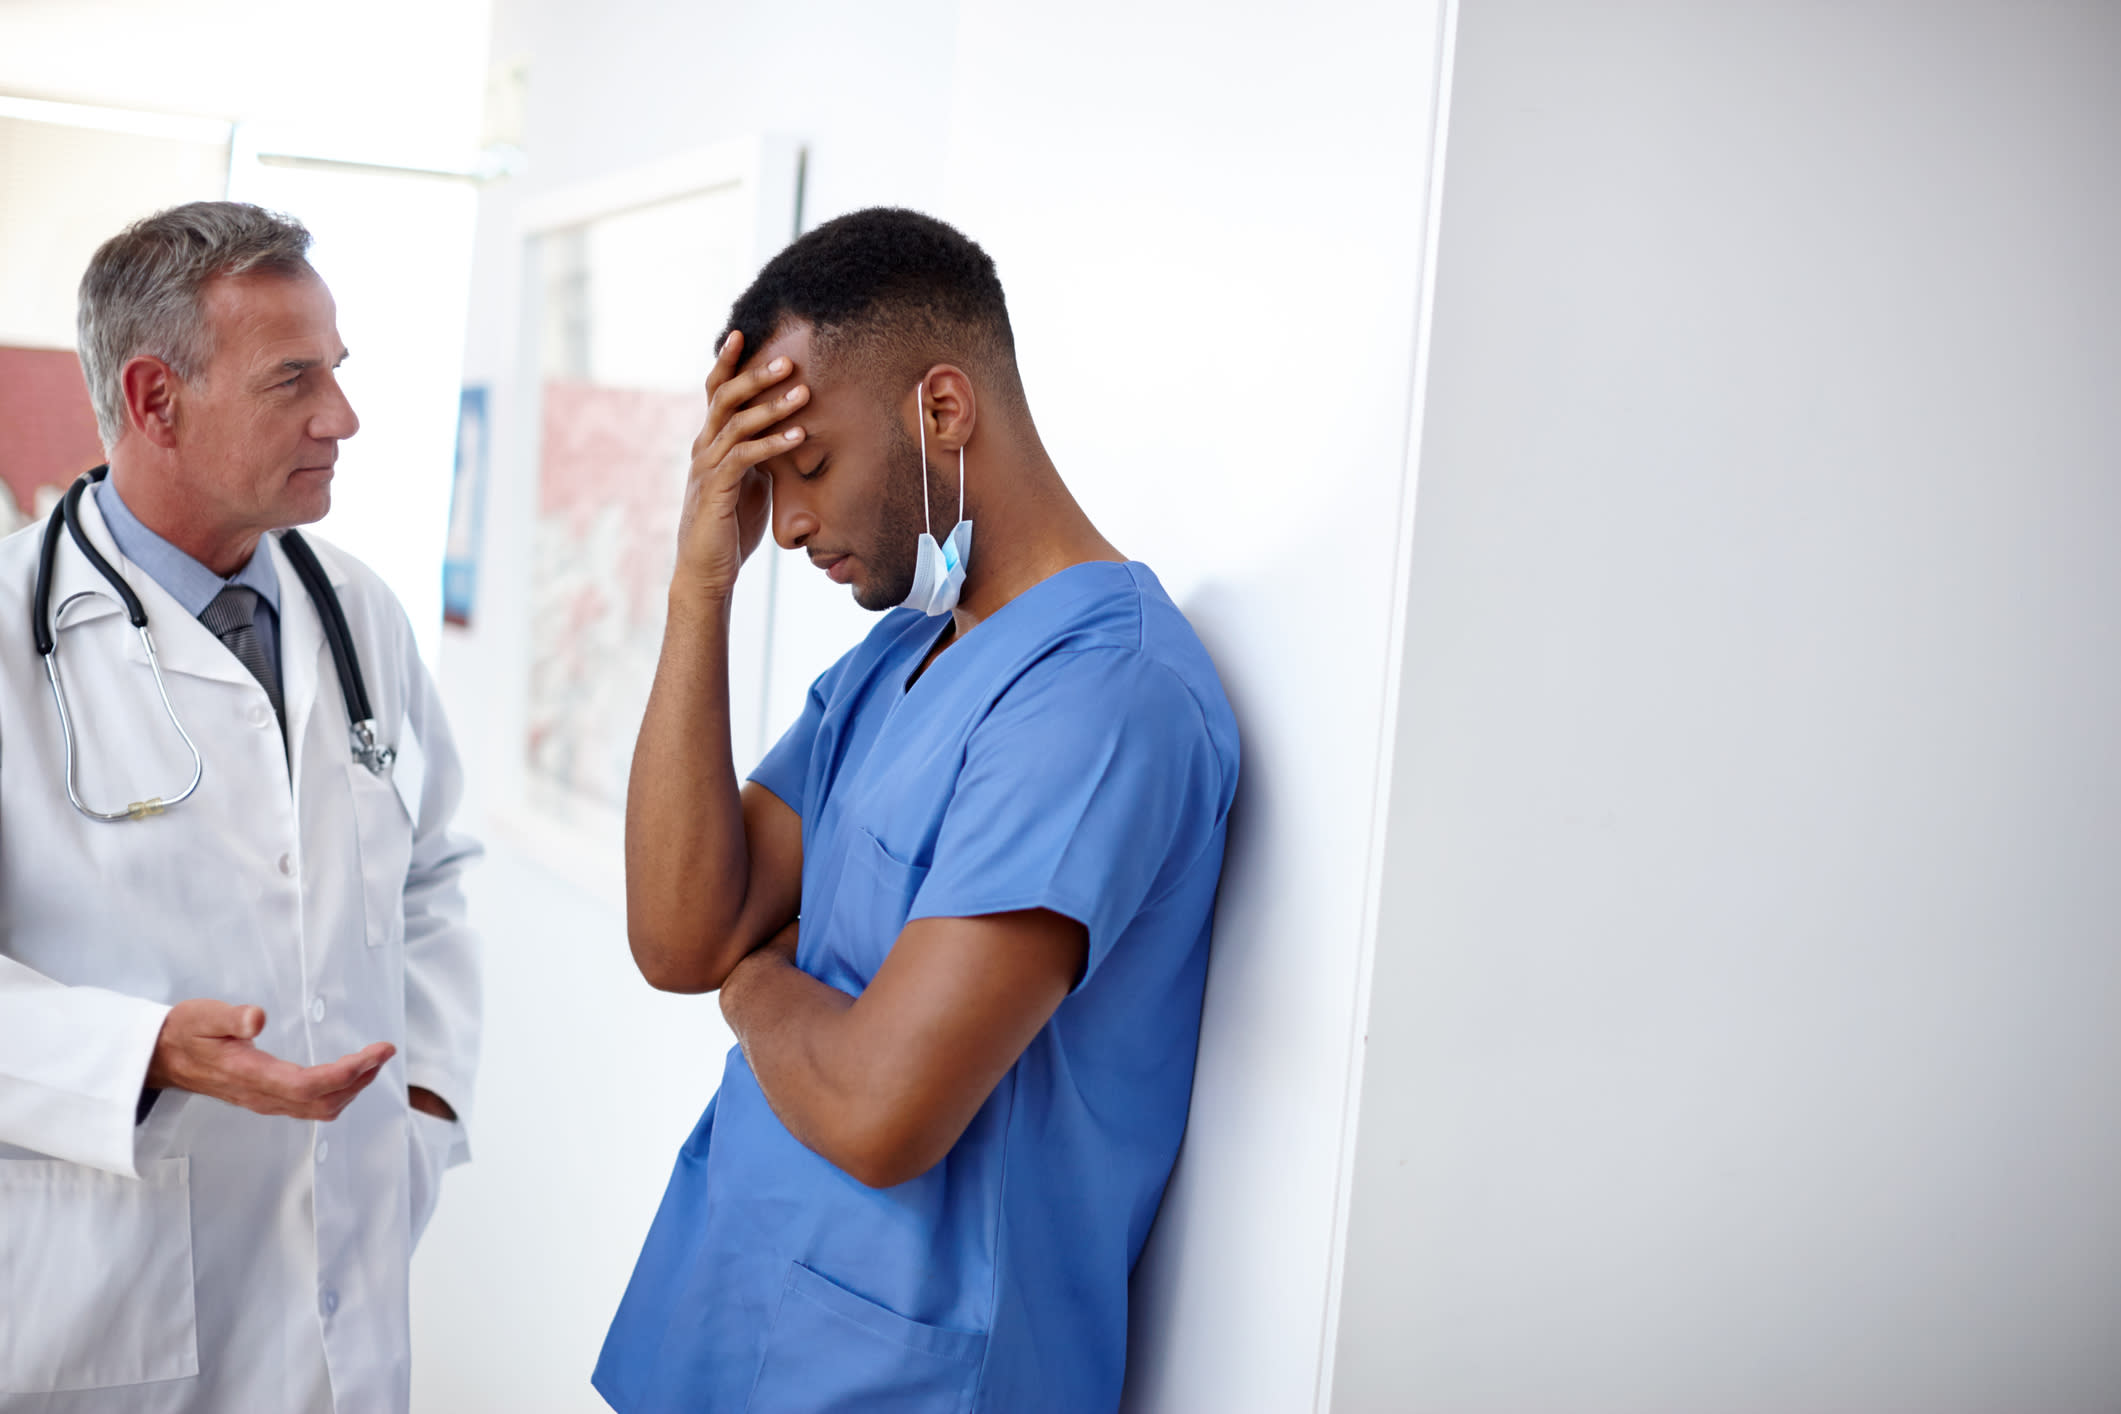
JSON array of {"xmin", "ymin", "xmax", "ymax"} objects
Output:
[{"xmin": 30, "ymin": 466, "xmax": 397, "ymax": 823}]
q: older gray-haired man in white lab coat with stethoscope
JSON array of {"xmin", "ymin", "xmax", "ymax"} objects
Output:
[{"xmin": 0, "ymin": 201, "xmax": 479, "ymax": 1414}]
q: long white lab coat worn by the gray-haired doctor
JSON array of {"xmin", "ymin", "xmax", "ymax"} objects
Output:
[{"xmin": 0, "ymin": 496, "xmax": 479, "ymax": 1414}]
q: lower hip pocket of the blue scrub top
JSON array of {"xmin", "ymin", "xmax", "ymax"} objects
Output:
[{"xmin": 744, "ymin": 1261, "xmax": 986, "ymax": 1414}]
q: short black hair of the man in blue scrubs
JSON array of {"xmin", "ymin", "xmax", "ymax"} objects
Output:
[{"xmin": 723, "ymin": 206, "xmax": 1024, "ymax": 405}]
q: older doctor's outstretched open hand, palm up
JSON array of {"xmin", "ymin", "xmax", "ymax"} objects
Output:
[{"xmin": 146, "ymin": 996, "xmax": 397, "ymax": 1119}]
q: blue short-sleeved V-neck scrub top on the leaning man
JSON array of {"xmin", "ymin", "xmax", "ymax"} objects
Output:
[{"xmin": 596, "ymin": 562, "xmax": 1237, "ymax": 1414}]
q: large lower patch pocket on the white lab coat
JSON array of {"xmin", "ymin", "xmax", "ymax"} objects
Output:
[{"xmin": 0, "ymin": 1157, "xmax": 199, "ymax": 1395}]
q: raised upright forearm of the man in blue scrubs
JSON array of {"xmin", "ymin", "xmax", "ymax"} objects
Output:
[{"xmin": 626, "ymin": 591, "xmax": 749, "ymax": 992}]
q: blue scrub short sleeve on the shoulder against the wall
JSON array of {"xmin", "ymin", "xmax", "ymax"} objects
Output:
[{"xmin": 910, "ymin": 649, "xmax": 1224, "ymax": 979}]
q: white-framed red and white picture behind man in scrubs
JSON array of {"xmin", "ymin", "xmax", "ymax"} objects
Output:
[{"xmin": 496, "ymin": 138, "xmax": 800, "ymax": 899}]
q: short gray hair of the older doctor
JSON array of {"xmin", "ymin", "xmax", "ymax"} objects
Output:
[{"xmin": 76, "ymin": 201, "xmax": 316, "ymax": 449}]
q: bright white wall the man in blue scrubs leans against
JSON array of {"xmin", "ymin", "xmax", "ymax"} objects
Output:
[{"xmin": 426, "ymin": 0, "xmax": 1438, "ymax": 1414}]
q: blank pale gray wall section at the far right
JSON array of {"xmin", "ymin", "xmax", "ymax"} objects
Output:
[{"xmin": 1332, "ymin": 0, "xmax": 2121, "ymax": 1414}]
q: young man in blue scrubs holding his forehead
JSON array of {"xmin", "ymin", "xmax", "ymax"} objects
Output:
[{"xmin": 596, "ymin": 210, "xmax": 1239, "ymax": 1414}]
